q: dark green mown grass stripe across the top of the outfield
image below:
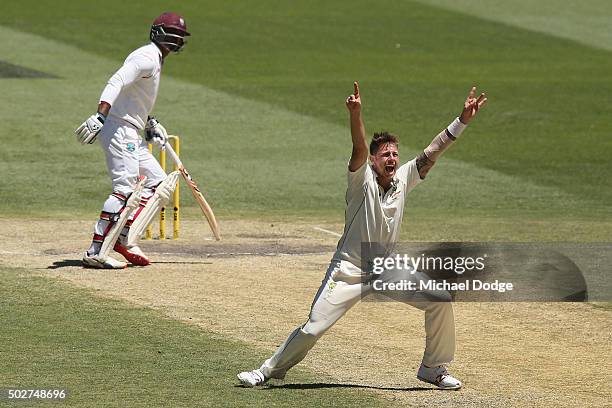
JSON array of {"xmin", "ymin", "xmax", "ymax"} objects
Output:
[{"xmin": 0, "ymin": 0, "xmax": 612, "ymax": 216}]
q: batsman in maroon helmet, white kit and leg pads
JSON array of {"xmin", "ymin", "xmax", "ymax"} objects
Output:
[{"xmin": 75, "ymin": 13, "xmax": 190, "ymax": 269}]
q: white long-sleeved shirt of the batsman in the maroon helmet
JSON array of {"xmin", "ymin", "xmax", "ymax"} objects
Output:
[{"xmin": 100, "ymin": 43, "xmax": 162, "ymax": 130}]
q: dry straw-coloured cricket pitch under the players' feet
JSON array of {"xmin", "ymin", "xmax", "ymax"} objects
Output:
[{"xmin": 0, "ymin": 219, "xmax": 612, "ymax": 407}]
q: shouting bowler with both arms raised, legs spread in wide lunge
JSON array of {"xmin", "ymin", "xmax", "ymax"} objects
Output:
[{"xmin": 238, "ymin": 82, "xmax": 487, "ymax": 389}]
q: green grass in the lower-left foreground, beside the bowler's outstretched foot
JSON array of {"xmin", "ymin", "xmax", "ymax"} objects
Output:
[{"xmin": 0, "ymin": 268, "xmax": 386, "ymax": 407}]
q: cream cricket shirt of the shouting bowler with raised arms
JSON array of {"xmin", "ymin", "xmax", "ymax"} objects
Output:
[{"xmin": 333, "ymin": 159, "xmax": 421, "ymax": 275}]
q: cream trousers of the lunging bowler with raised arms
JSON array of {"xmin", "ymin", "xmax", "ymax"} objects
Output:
[{"xmin": 261, "ymin": 260, "xmax": 455, "ymax": 378}]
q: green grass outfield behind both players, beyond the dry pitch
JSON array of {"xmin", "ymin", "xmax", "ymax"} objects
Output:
[{"xmin": 0, "ymin": 0, "xmax": 612, "ymax": 240}]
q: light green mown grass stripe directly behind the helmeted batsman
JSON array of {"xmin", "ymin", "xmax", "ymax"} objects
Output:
[{"xmin": 0, "ymin": 27, "xmax": 596, "ymax": 226}]
